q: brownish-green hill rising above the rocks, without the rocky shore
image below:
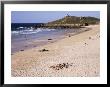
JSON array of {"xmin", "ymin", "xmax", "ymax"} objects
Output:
[{"xmin": 47, "ymin": 16, "xmax": 100, "ymax": 25}]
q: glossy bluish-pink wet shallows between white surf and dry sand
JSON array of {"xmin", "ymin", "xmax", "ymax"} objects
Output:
[{"xmin": 11, "ymin": 28, "xmax": 90, "ymax": 54}]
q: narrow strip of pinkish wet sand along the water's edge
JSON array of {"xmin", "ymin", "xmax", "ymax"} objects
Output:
[{"xmin": 11, "ymin": 27, "xmax": 90, "ymax": 55}]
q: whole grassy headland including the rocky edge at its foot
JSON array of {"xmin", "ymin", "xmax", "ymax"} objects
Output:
[{"xmin": 37, "ymin": 16, "xmax": 100, "ymax": 29}]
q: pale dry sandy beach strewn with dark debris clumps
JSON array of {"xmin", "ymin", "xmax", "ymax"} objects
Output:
[{"xmin": 11, "ymin": 25, "xmax": 100, "ymax": 77}]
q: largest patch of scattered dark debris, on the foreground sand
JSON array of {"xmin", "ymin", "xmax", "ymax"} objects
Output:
[{"xmin": 49, "ymin": 63, "xmax": 73, "ymax": 70}]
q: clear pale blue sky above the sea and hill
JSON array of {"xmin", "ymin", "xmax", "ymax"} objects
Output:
[{"xmin": 11, "ymin": 11, "xmax": 100, "ymax": 23}]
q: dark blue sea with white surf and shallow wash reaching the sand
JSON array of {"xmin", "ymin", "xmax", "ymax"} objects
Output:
[{"xmin": 11, "ymin": 23, "xmax": 87, "ymax": 53}]
